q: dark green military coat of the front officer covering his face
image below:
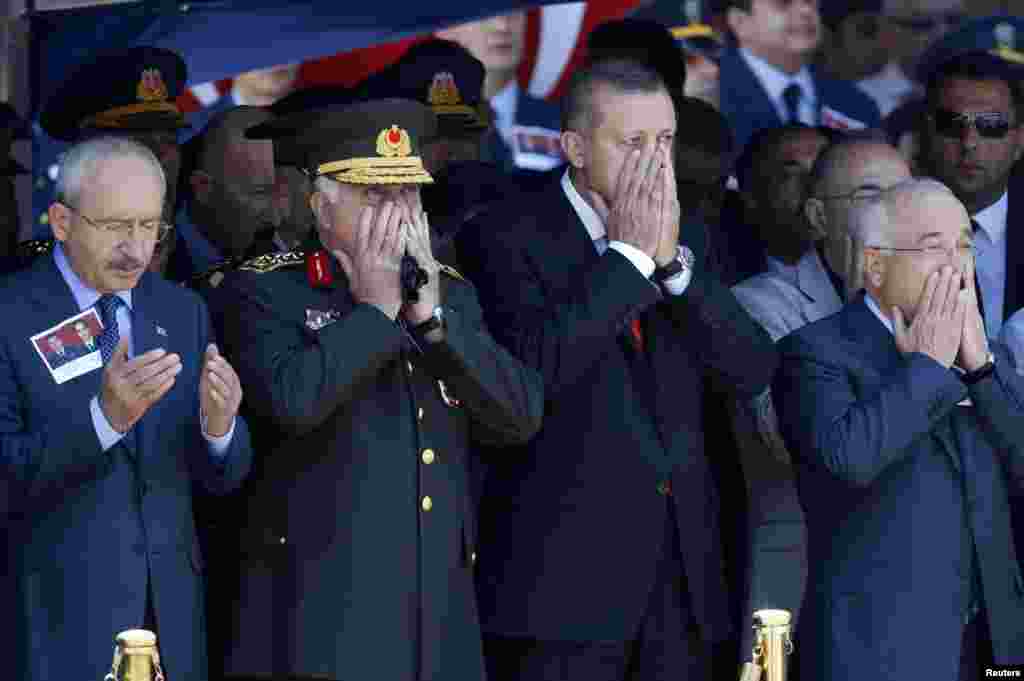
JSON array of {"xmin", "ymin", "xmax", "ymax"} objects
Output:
[{"xmin": 208, "ymin": 255, "xmax": 543, "ymax": 681}]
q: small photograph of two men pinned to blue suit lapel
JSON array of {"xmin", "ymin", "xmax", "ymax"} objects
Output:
[{"xmin": 29, "ymin": 307, "xmax": 103, "ymax": 385}]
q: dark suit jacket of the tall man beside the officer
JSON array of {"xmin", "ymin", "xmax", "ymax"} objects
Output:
[{"xmin": 458, "ymin": 176, "xmax": 775, "ymax": 641}]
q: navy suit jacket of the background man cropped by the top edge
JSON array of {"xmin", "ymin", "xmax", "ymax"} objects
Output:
[{"xmin": 719, "ymin": 47, "xmax": 882, "ymax": 148}]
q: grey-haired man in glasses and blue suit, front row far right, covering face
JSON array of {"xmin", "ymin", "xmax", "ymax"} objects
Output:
[{"xmin": 772, "ymin": 179, "xmax": 1024, "ymax": 681}]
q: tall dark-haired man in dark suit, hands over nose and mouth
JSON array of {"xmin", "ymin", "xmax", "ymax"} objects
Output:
[{"xmin": 458, "ymin": 59, "xmax": 774, "ymax": 681}]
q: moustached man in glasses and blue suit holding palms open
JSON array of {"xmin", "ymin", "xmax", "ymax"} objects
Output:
[{"xmin": 0, "ymin": 137, "xmax": 251, "ymax": 681}]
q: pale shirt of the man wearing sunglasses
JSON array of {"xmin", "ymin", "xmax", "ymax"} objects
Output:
[{"xmin": 974, "ymin": 193, "xmax": 1010, "ymax": 338}]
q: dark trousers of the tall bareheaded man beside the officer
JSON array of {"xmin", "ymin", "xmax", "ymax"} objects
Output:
[{"xmin": 483, "ymin": 499, "xmax": 711, "ymax": 681}]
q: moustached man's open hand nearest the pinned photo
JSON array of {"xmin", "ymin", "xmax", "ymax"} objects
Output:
[{"xmin": 99, "ymin": 338, "xmax": 181, "ymax": 433}]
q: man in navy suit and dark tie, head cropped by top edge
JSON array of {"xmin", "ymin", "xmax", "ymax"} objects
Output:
[{"xmin": 719, "ymin": 0, "xmax": 881, "ymax": 148}]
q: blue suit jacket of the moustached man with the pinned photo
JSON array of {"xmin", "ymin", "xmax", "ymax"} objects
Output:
[{"xmin": 0, "ymin": 256, "xmax": 250, "ymax": 681}]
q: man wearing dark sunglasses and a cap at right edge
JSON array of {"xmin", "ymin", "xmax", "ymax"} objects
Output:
[{"xmin": 920, "ymin": 23, "xmax": 1024, "ymax": 338}]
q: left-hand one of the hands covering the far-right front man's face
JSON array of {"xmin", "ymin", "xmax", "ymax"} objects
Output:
[{"xmin": 892, "ymin": 265, "xmax": 968, "ymax": 369}]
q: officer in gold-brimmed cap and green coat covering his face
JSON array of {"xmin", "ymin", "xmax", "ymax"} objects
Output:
[{"xmin": 214, "ymin": 99, "xmax": 543, "ymax": 681}]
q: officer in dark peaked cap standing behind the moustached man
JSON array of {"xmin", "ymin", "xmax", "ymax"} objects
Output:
[{"xmin": 16, "ymin": 46, "xmax": 187, "ymax": 273}]
